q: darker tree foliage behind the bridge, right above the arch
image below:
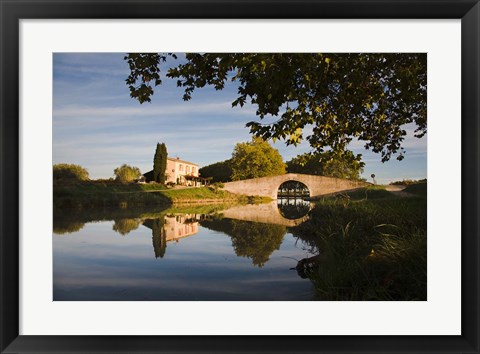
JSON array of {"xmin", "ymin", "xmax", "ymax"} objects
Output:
[{"xmin": 287, "ymin": 152, "xmax": 365, "ymax": 180}]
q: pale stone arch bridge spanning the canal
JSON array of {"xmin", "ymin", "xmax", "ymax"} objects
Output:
[{"xmin": 223, "ymin": 173, "xmax": 368, "ymax": 199}]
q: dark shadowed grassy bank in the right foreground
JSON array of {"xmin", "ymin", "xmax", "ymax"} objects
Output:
[{"xmin": 292, "ymin": 183, "xmax": 427, "ymax": 300}]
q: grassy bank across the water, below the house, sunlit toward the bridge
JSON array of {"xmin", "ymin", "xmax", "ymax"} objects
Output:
[{"xmin": 53, "ymin": 181, "xmax": 264, "ymax": 208}]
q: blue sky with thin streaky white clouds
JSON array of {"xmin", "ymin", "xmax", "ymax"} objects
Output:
[{"xmin": 53, "ymin": 53, "xmax": 427, "ymax": 183}]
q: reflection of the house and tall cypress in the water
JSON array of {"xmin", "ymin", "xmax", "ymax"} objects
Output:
[{"xmin": 143, "ymin": 214, "xmax": 198, "ymax": 258}]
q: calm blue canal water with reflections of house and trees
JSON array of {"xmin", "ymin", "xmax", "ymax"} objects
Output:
[{"xmin": 53, "ymin": 198, "xmax": 314, "ymax": 301}]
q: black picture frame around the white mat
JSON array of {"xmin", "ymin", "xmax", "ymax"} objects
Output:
[{"xmin": 0, "ymin": 0, "xmax": 480, "ymax": 353}]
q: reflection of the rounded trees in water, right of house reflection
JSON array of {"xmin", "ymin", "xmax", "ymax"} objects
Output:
[{"xmin": 200, "ymin": 219, "xmax": 287, "ymax": 267}]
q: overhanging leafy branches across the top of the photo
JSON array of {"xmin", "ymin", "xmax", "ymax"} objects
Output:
[{"xmin": 125, "ymin": 53, "xmax": 427, "ymax": 161}]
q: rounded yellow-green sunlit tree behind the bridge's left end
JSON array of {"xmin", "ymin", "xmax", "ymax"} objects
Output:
[{"xmin": 231, "ymin": 137, "xmax": 286, "ymax": 181}]
